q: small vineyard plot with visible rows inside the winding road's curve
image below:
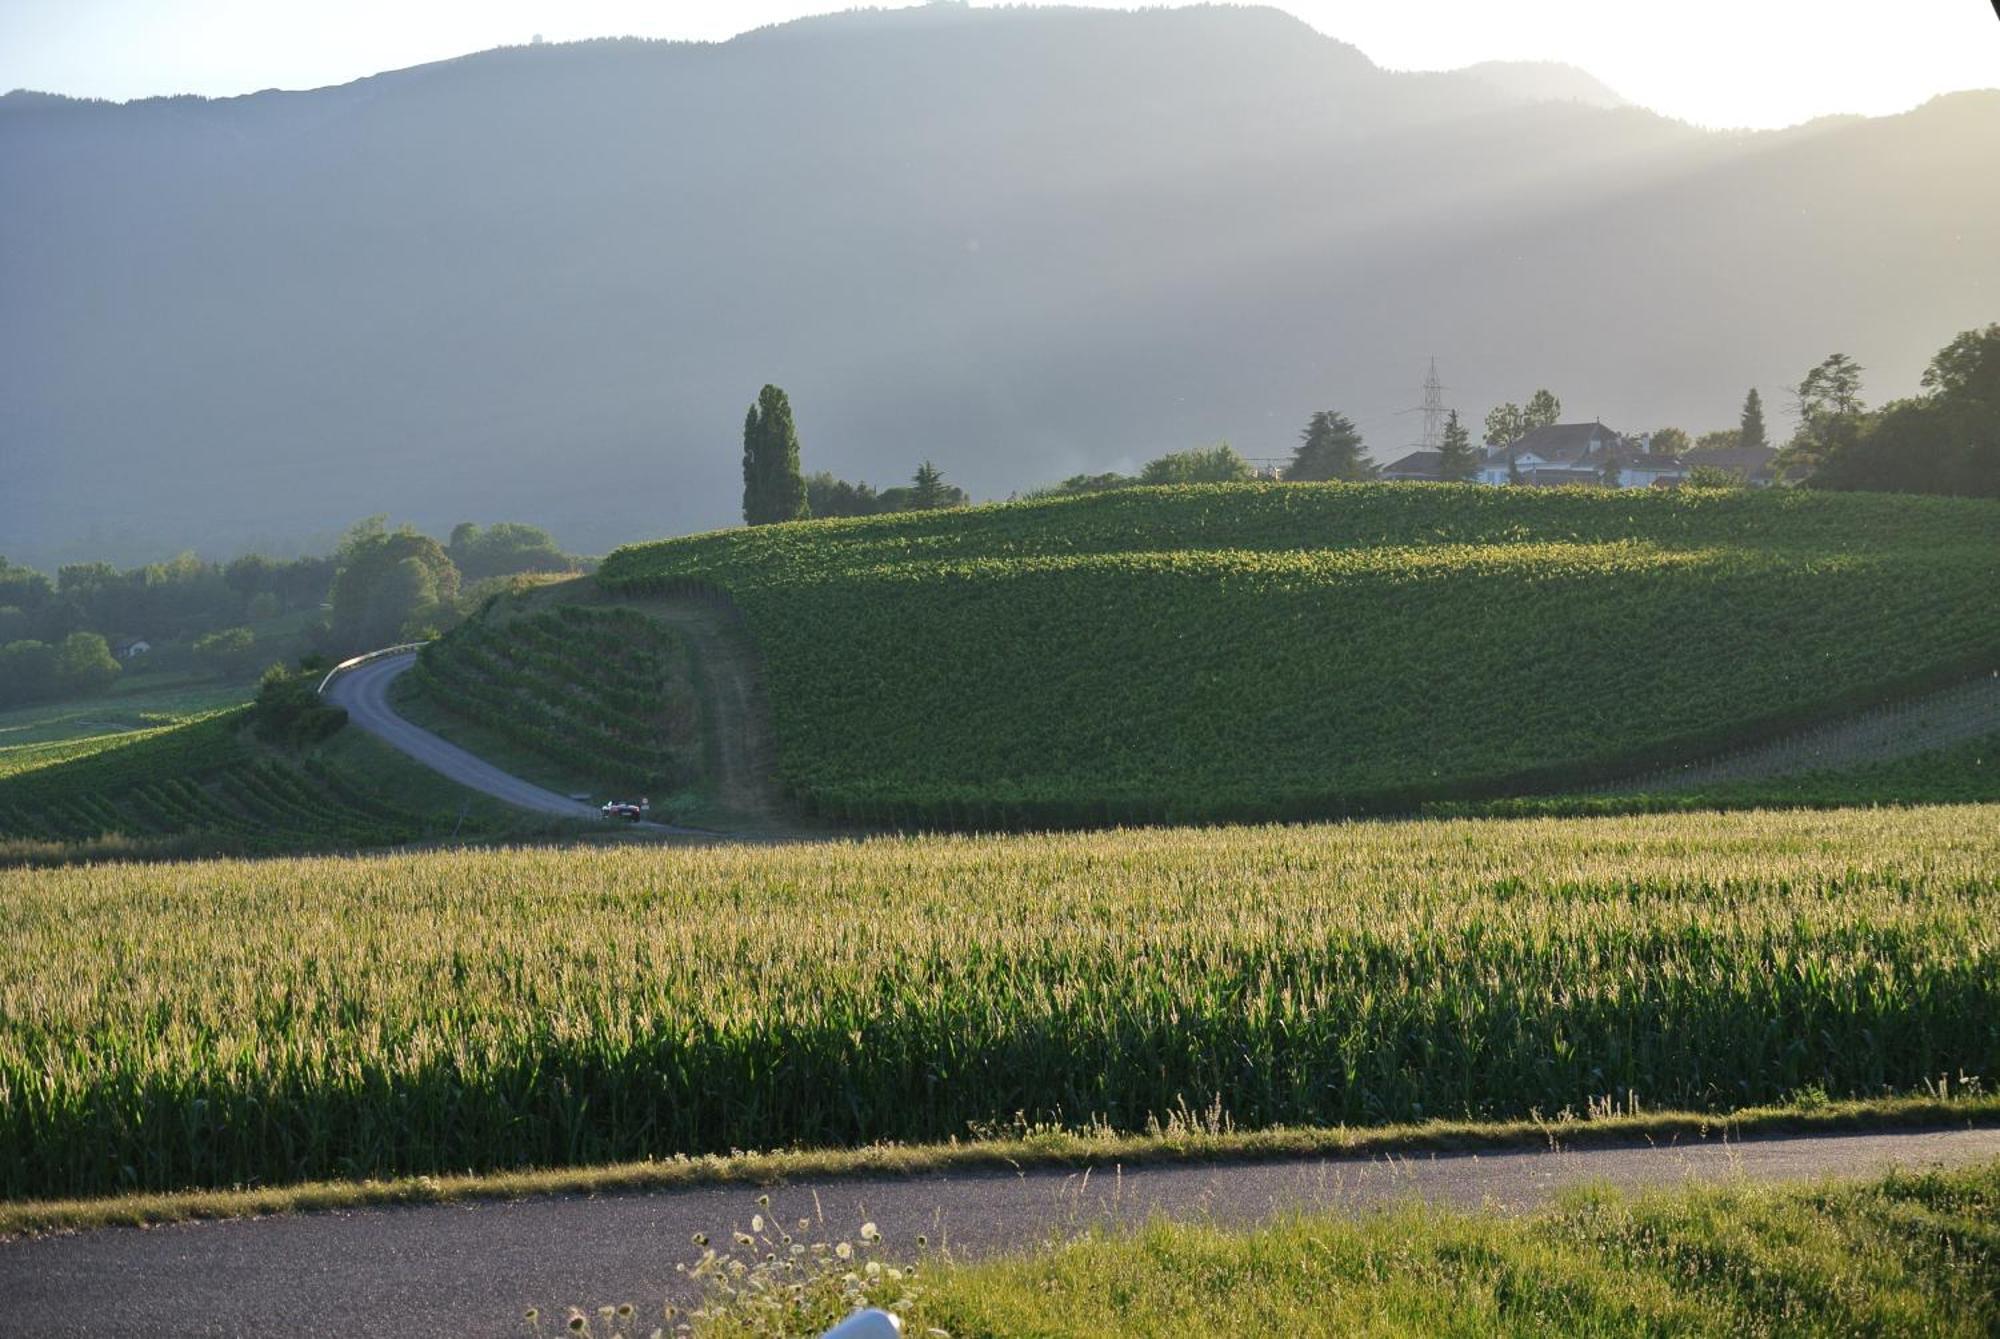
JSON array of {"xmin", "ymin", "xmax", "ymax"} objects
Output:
[{"xmin": 410, "ymin": 606, "xmax": 698, "ymax": 795}]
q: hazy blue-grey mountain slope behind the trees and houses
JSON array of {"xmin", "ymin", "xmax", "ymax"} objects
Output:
[{"xmin": 0, "ymin": 6, "xmax": 2000, "ymax": 564}]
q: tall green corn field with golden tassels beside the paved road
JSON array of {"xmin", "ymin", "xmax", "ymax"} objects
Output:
[{"xmin": 0, "ymin": 807, "xmax": 2000, "ymax": 1197}]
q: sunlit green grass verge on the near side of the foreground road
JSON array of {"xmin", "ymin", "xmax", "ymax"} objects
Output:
[{"xmin": 840, "ymin": 1163, "xmax": 2000, "ymax": 1339}]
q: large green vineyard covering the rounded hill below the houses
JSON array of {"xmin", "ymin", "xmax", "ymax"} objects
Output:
[{"xmin": 598, "ymin": 484, "xmax": 2000, "ymax": 825}]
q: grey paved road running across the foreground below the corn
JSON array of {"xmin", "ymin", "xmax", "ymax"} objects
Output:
[{"xmin": 0, "ymin": 1129, "xmax": 2000, "ymax": 1339}]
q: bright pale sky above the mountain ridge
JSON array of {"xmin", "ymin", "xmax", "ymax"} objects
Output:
[{"xmin": 0, "ymin": 0, "xmax": 2000, "ymax": 126}]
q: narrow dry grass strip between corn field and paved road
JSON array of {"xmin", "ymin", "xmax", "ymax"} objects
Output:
[{"xmin": 0, "ymin": 1095, "xmax": 2000, "ymax": 1237}]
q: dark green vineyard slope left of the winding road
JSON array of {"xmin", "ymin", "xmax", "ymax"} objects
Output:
[{"xmin": 0, "ymin": 707, "xmax": 454, "ymax": 851}]
